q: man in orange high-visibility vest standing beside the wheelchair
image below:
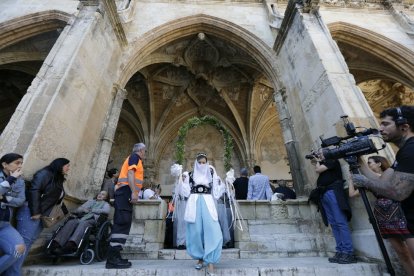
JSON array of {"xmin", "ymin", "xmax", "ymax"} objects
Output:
[{"xmin": 106, "ymin": 143, "xmax": 145, "ymax": 268}]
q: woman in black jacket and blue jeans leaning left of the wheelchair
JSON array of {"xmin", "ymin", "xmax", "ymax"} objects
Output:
[{"xmin": 13, "ymin": 158, "xmax": 70, "ymax": 275}]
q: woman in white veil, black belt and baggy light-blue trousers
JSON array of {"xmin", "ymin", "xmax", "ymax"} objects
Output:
[{"xmin": 183, "ymin": 153, "xmax": 224, "ymax": 275}]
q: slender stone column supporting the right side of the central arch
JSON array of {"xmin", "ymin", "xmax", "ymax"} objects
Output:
[{"xmin": 273, "ymin": 88, "xmax": 305, "ymax": 195}]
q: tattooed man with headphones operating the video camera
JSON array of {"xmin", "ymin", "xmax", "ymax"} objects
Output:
[{"xmin": 352, "ymin": 106, "xmax": 414, "ymax": 258}]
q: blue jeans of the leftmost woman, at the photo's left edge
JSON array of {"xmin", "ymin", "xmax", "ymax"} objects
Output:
[{"xmin": 0, "ymin": 222, "xmax": 24, "ymax": 276}]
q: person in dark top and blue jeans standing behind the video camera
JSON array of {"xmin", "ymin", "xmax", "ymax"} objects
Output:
[{"xmin": 311, "ymin": 154, "xmax": 357, "ymax": 264}]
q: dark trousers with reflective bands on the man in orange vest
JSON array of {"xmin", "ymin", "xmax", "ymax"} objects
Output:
[{"xmin": 109, "ymin": 186, "xmax": 132, "ymax": 250}]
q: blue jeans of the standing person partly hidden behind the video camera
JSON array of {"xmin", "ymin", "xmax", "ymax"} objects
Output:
[{"xmin": 322, "ymin": 190, "xmax": 354, "ymax": 254}]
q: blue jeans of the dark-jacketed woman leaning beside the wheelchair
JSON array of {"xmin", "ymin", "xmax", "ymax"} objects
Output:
[{"xmin": 7, "ymin": 202, "xmax": 43, "ymax": 275}]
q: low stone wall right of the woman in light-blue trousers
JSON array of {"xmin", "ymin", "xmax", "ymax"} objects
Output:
[{"xmin": 234, "ymin": 198, "xmax": 335, "ymax": 259}]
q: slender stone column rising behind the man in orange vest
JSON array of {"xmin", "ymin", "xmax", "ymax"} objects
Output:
[{"xmin": 93, "ymin": 84, "xmax": 128, "ymax": 192}]
